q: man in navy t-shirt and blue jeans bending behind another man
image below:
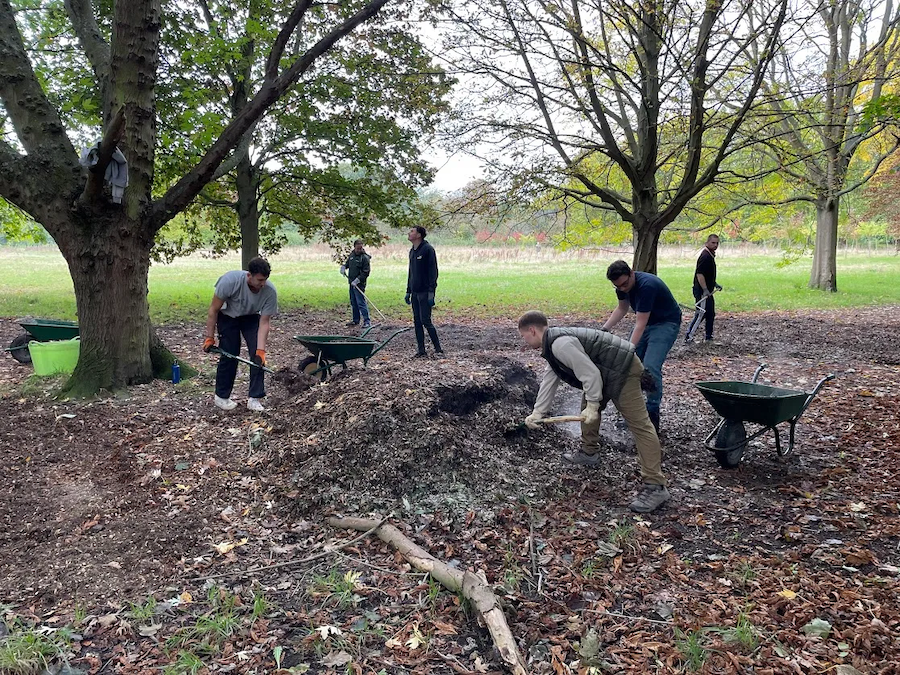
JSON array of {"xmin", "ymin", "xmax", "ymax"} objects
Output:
[{"xmin": 602, "ymin": 260, "xmax": 681, "ymax": 432}]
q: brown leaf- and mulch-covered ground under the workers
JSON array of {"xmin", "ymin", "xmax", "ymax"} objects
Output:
[{"xmin": 0, "ymin": 307, "xmax": 900, "ymax": 673}]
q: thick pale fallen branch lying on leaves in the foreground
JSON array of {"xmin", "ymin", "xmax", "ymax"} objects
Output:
[{"xmin": 326, "ymin": 517, "xmax": 527, "ymax": 675}]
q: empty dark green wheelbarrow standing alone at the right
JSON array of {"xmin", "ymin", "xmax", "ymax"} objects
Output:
[{"xmin": 695, "ymin": 364, "xmax": 834, "ymax": 469}]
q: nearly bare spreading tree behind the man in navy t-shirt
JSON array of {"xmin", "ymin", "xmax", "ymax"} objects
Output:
[{"xmin": 444, "ymin": 0, "xmax": 787, "ymax": 272}]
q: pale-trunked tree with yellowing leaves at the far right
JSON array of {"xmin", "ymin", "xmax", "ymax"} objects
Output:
[{"xmin": 756, "ymin": 0, "xmax": 900, "ymax": 291}]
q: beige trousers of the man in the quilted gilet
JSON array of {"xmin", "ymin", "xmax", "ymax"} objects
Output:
[{"xmin": 581, "ymin": 357, "xmax": 666, "ymax": 485}]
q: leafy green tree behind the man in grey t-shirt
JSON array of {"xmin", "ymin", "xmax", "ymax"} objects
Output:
[{"xmin": 158, "ymin": 0, "xmax": 450, "ymax": 264}]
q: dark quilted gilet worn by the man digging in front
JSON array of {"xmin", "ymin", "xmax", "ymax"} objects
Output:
[{"xmin": 541, "ymin": 328, "xmax": 634, "ymax": 401}]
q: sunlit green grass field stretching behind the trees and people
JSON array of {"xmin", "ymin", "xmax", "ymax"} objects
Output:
[{"xmin": 0, "ymin": 244, "xmax": 900, "ymax": 323}]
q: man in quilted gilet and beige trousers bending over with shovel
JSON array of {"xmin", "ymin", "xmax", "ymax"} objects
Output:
[{"xmin": 519, "ymin": 310, "xmax": 670, "ymax": 513}]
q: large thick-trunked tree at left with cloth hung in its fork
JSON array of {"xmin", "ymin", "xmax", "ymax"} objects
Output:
[{"xmin": 0, "ymin": 0, "xmax": 400, "ymax": 395}]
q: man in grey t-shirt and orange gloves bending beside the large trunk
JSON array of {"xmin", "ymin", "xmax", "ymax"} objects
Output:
[{"xmin": 203, "ymin": 258, "xmax": 278, "ymax": 411}]
